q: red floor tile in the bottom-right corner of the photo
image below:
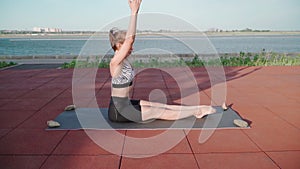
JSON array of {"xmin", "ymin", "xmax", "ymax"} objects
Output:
[{"xmin": 266, "ymin": 151, "xmax": 300, "ymax": 169}]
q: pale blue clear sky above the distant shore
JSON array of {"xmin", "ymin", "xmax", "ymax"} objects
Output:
[{"xmin": 0, "ymin": 0, "xmax": 300, "ymax": 31}]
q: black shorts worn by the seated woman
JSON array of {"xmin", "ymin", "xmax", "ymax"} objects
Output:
[{"xmin": 108, "ymin": 97, "xmax": 142, "ymax": 122}]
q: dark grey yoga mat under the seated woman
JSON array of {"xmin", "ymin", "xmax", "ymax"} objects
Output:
[{"xmin": 47, "ymin": 107, "xmax": 248, "ymax": 130}]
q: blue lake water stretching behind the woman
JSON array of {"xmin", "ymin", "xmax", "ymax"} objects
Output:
[{"xmin": 0, "ymin": 35, "xmax": 300, "ymax": 57}]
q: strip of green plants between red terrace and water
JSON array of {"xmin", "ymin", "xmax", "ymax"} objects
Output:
[{"xmin": 62, "ymin": 52, "xmax": 300, "ymax": 68}]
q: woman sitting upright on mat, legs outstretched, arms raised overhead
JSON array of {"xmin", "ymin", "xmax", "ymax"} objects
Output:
[{"xmin": 108, "ymin": 0, "xmax": 216, "ymax": 122}]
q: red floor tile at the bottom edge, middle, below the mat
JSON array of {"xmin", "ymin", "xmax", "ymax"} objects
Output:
[{"xmin": 121, "ymin": 154, "xmax": 198, "ymax": 169}]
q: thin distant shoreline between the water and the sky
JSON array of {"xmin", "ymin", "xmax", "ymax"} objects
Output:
[{"xmin": 0, "ymin": 31, "xmax": 300, "ymax": 38}]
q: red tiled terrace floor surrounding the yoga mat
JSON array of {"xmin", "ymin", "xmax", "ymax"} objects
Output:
[{"xmin": 0, "ymin": 66, "xmax": 300, "ymax": 169}]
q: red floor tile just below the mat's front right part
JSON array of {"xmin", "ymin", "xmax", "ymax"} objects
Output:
[{"xmin": 187, "ymin": 129, "xmax": 260, "ymax": 153}]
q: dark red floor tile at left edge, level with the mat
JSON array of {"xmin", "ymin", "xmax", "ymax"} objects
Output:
[{"xmin": 0, "ymin": 110, "xmax": 36, "ymax": 129}]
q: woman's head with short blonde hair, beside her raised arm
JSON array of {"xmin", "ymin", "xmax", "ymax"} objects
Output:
[{"xmin": 109, "ymin": 28, "xmax": 126, "ymax": 51}]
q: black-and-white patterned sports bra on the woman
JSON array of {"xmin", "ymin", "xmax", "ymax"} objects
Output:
[{"xmin": 112, "ymin": 59, "xmax": 134, "ymax": 88}]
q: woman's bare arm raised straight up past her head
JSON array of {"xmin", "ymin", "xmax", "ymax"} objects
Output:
[{"xmin": 110, "ymin": 0, "xmax": 142, "ymax": 67}]
